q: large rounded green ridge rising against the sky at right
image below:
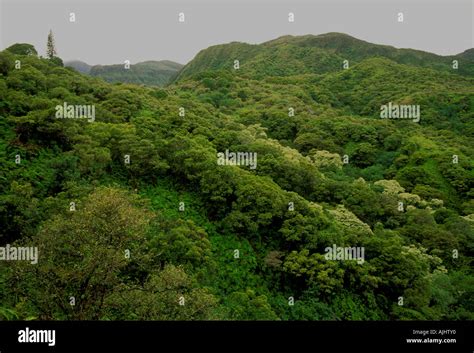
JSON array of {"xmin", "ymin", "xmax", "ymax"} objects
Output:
[{"xmin": 178, "ymin": 33, "xmax": 474, "ymax": 79}]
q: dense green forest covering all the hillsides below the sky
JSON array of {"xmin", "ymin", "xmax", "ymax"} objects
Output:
[{"xmin": 0, "ymin": 34, "xmax": 474, "ymax": 320}]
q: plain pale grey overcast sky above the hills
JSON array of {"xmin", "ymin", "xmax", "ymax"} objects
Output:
[{"xmin": 0, "ymin": 0, "xmax": 474, "ymax": 64}]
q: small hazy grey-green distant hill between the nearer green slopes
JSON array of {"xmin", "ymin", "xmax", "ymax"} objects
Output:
[{"xmin": 66, "ymin": 60, "xmax": 183, "ymax": 86}]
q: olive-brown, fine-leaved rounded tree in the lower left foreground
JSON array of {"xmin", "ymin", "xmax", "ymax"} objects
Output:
[{"xmin": 6, "ymin": 188, "xmax": 150, "ymax": 320}]
